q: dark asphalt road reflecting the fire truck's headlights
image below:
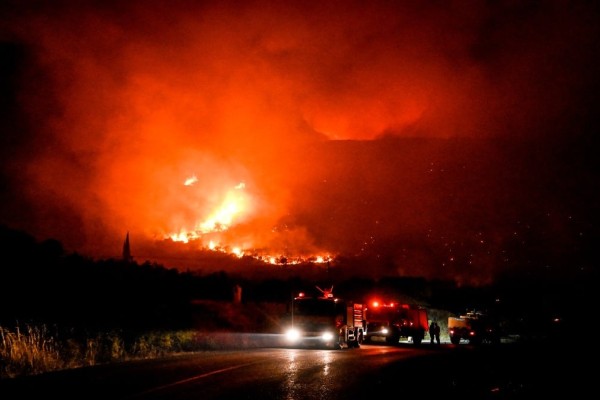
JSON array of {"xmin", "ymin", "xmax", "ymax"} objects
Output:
[{"xmin": 0, "ymin": 343, "xmax": 594, "ymax": 400}]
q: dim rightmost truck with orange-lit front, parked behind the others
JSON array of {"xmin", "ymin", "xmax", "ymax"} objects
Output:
[{"xmin": 448, "ymin": 311, "xmax": 501, "ymax": 344}]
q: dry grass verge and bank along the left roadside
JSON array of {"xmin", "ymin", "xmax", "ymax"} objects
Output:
[{"xmin": 0, "ymin": 301, "xmax": 284, "ymax": 379}]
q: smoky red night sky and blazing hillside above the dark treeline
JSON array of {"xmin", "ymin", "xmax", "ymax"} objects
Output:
[{"xmin": 0, "ymin": 0, "xmax": 600, "ymax": 284}]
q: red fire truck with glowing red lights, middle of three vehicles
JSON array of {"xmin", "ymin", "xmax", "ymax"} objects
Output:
[{"xmin": 364, "ymin": 301, "xmax": 428, "ymax": 345}]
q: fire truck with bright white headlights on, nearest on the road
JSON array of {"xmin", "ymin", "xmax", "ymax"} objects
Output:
[{"xmin": 285, "ymin": 286, "xmax": 365, "ymax": 349}]
